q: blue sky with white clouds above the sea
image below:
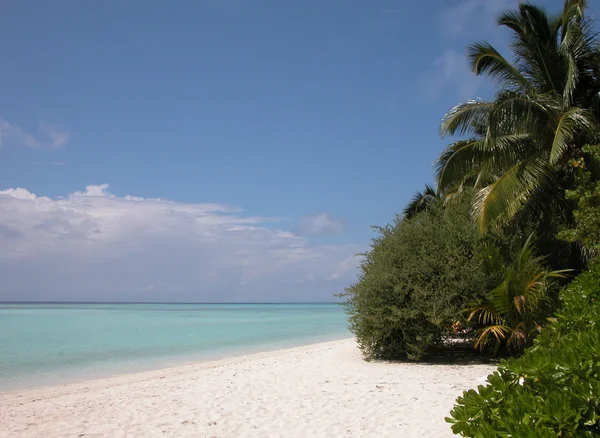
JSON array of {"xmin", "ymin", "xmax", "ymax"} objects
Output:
[{"xmin": 0, "ymin": 0, "xmax": 597, "ymax": 302}]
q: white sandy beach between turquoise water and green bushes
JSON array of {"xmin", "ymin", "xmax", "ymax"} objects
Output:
[{"xmin": 0, "ymin": 339, "xmax": 494, "ymax": 437}]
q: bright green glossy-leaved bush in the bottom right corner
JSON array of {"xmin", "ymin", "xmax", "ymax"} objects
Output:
[{"xmin": 447, "ymin": 264, "xmax": 600, "ymax": 437}]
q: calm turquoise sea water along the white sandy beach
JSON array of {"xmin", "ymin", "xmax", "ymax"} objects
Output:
[{"xmin": 0, "ymin": 304, "xmax": 350, "ymax": 390}]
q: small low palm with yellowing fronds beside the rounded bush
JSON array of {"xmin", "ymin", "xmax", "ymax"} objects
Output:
[{"xmin": 467, "ymin": 235, "xmax": 570, "ymax": 352}]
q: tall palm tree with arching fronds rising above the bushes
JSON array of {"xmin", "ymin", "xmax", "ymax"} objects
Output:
[{"xmin": 436, "ymin": 0, "xmax": 600, "ymax": 231}]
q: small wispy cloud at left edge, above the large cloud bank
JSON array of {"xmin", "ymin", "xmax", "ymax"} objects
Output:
[{"xmin": 0, "ymin": 119, "xmax": 71, "ymax": 149}]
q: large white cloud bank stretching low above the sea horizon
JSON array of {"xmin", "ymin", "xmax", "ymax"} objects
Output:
[{"xmin": 0, "ymin": 184, "xmax": 364, "ymax": 301}]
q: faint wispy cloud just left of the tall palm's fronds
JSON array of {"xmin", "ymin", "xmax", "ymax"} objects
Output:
[{"xmin": 419, "ymin": 49, "xmax": 483, "ymax": 100}]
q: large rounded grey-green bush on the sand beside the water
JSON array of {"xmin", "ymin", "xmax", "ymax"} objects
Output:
[{"xmin": 343, "ymin": 196, "xmax": 490, "ymax": 359}]
